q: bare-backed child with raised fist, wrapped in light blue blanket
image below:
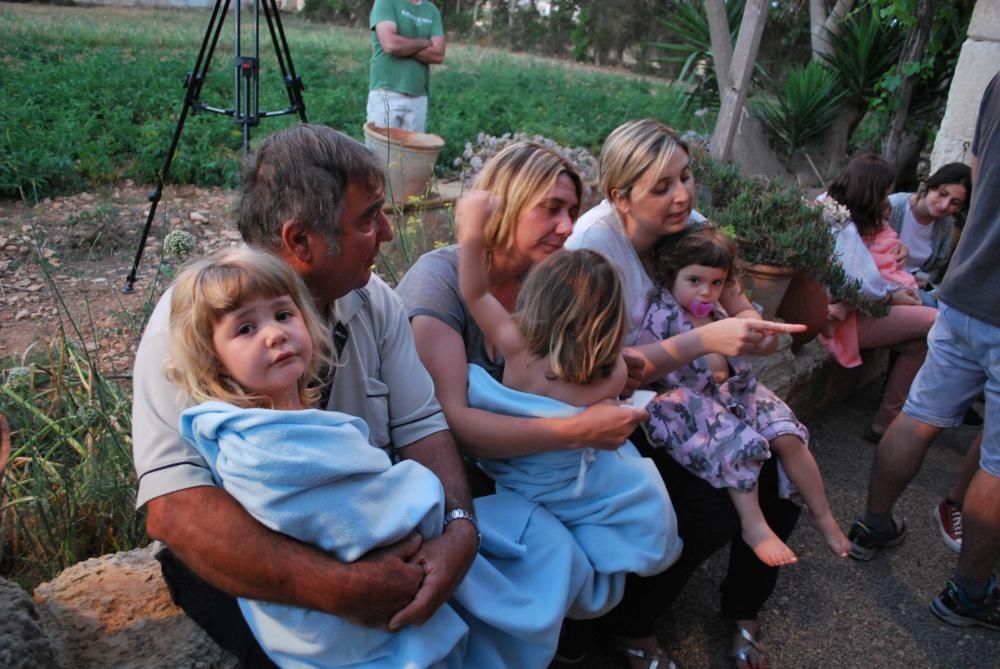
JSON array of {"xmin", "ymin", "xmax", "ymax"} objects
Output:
[{"xmin": 456, "ymin": 192, "xmax": 681, "ymax": 617}]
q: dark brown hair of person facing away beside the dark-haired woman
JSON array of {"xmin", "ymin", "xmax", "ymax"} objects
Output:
[{"xmin": 827, "ymin": 153, "xmax": 896, "ymax": 237}]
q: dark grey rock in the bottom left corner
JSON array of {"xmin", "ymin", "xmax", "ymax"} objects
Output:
[{"xmin": 0, "ymin": 578, "xmax": 63, "ymax": 669}]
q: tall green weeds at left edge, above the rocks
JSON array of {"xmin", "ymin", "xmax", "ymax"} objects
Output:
[{"xmin": 0, "ymin": 339, "xmax": 148, "ymax": 585}]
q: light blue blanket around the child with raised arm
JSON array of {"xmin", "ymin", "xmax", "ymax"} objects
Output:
[{"xmin": 469, "ymin": 365, "xmax": 682, "ymax": 617}]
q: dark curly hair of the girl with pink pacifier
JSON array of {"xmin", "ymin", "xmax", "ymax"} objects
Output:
[{"xmin": 650, "ymin": 225, "xmax": 742, "ymax": 291}]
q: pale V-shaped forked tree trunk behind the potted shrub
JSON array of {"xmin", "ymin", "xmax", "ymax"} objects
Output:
[{"xmin": 705, "ymin": 0, "xmax": 768, "ymax": 162}]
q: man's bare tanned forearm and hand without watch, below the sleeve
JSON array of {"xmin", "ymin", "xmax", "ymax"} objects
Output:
[{"xmin": 146, "ymin": 486, "xmax": 424, "ymax": 628}]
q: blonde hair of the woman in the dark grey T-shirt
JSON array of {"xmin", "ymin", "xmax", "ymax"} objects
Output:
[{"xmin": 473, "ymin": 142, "xmax": 583, "ymax": 254}]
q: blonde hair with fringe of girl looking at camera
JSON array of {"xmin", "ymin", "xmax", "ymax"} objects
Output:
[{"xmin": 166, "ymin": 247, "xmax": 332, "ymax": 408}]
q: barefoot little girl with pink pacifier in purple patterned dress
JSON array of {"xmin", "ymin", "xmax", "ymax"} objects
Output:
[{"xmin": 639, "ymin": 225, "xmax": 850, "ymax": 566}]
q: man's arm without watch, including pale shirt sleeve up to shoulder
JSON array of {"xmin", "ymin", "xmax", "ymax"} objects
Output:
[{"xmin": 132, "ymin": 291, "xmax": 423, "ymax": 627}]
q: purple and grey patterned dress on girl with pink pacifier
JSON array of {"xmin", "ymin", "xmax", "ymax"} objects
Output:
[{"xmin": 638, "ymin": 289, "xmax": 809, "ymax": 498}]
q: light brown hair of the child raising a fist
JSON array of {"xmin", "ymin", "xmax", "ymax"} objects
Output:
[{"xmin": 516, "ymin": 249, "xmax": 625, "ymax": 384}]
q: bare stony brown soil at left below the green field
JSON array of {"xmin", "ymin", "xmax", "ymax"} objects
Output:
[{"xmin": 0, "ymin": 182, "xmax": 239, "ymax": 372}]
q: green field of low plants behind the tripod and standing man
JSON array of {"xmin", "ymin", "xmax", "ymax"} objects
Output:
[{"xmin": 0, "ymin": 4, "xmax": 692, "ymax": 201}]
